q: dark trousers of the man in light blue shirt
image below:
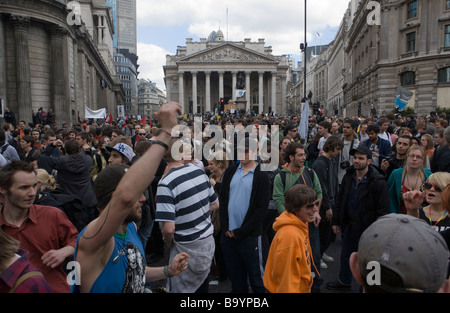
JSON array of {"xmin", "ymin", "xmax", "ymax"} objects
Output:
[{"xmin": 220, "ymin": 234, "xmax": 266, "ymax": 293}]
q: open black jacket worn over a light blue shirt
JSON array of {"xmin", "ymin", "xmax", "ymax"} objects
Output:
[{"xmin": 219, "ymin": 164, "xmax": 271, "ymax": 240}]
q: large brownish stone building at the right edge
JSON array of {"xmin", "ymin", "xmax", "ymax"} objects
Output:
[{"xmin": 344, "ymin": 0, "xmax": 450, "ymax": 115}]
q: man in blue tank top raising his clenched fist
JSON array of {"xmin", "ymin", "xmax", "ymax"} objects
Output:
[{"xmin": 68, "ymin": 102, "xmax": 189, "ymax": 293}]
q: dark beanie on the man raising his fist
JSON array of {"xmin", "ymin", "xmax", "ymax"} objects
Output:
[{"xmin": 94, "ymin": 164, "xmax": 130, "ymax": 209}]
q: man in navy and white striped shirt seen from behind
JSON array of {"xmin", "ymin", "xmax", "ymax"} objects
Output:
[{"xmin": 155, "ymin": 146, "xmax": 219, "ymax": 293}]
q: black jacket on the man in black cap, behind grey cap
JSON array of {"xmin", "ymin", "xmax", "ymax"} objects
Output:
[{"xmin": 332, "ymin": 165, "xmax": 389, "ymax": 237}]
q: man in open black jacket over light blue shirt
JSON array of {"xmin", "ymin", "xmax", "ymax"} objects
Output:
[{"xmin": 219, "ymin": 137, "xmax": 271, "ymax": 293}]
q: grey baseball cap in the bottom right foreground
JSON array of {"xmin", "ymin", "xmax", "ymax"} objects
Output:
[{"xmin": 358, "ymin": 213, "xmax": 450, "ymax": 293}]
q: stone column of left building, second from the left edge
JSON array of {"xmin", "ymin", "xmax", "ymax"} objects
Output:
[{"xmin": 47, "ymin": 24, "xmax": 69, "ymax": 125}]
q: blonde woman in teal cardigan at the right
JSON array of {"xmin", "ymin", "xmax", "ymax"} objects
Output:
[{"xmin": 388, "ymin": 145, "xmax": 431, "ymax": 214}]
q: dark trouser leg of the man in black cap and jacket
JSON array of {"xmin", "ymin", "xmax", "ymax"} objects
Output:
[{"xmin": 339, "ymin": 226, "xmax": 360, "ymax": 286}]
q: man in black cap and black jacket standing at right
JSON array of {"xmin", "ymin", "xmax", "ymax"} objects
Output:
[{"xmin": 327, "ymin": 144, "xmax": 389, "ymax": 291}]
